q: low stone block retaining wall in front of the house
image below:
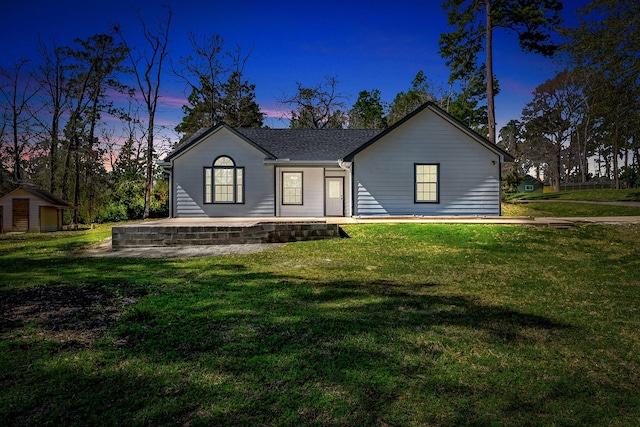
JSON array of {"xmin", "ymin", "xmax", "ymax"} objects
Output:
[{"xmin": 111, "ymin": 223, "xmax": 340, "ymax": 249}]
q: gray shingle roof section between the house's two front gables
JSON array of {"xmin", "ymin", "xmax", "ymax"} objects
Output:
[{"xmin": 236, "ymin": 128, "xmax": 381, "ymax": 161}]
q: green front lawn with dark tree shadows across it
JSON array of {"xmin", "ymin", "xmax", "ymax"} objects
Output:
[{"xmin": 0, "ymin": 224, "xmax": 640, "ymax": 426}]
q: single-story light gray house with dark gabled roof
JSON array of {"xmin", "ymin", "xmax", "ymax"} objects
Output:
[{"xmin": 160, "ymin": 103, "xmax": 513, "ymax": 217}]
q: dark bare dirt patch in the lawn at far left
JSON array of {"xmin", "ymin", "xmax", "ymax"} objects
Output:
[{"xmin": 0, "ymin": 286, "xmax": 140, "ymax": 347}]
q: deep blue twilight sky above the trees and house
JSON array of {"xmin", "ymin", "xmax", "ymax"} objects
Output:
[{"xmin": 0, "ymin": 0, "xmax": 588, "ymax": 138}]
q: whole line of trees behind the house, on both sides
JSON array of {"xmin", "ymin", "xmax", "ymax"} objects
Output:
[{"xmin": 0, "ymin": 0, "xmax": 640, "ymax": 222}]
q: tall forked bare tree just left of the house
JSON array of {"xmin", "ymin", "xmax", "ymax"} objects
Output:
[{"xmin": 116, "ymin": 6, "xmax": 172, "ymax": 219}]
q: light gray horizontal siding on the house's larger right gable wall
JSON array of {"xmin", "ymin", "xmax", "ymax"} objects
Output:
[{"xmin": 353, "ymin": 109, "xmax": 500, "ymax": 216}]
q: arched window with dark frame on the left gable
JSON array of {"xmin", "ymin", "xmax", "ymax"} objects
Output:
[{"xmin": 204, "ymin": 156, "xmax": 244, "ymax": 203}]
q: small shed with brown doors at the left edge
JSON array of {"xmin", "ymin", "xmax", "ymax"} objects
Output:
[{"xmin": 0, "ymin": 187, "xmax": 75, "ymax": 233}]
